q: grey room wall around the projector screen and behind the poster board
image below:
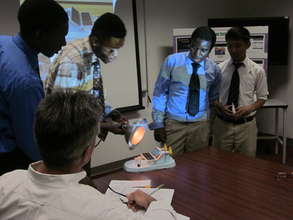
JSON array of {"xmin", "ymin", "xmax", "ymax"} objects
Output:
[{"xmin": 0, "ymin": 0, "xmax": 293, "ymax": 167}]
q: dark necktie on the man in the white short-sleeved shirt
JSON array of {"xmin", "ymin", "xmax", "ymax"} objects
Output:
[{"xmin": 227, "ymin": 63, "xmax": 243, "ymax": 108}]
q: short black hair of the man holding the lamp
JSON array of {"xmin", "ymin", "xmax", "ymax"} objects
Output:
[{"xmin": 90, "ymin": 12, "xmax": 126, "ymax": 43}]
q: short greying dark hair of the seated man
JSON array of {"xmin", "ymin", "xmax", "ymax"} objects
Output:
[{"xmin": 34, "ymin": 89, "xmax": 102, "ymax": 169}]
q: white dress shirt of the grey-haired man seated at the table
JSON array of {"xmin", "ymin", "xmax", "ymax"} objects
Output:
[{"xmin": 0, "ymin": 161, "xmax": 176, "ymax": 220}]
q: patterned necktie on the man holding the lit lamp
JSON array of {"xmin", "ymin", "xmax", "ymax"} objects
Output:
[{"xmin": 92, "ymin": 60, "xmax": 105, "ymax": 113}]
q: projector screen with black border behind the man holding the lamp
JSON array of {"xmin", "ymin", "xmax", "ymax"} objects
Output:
[{"xmin": 20, "ymin": 0, "xmax": 144, "ymax": 111}]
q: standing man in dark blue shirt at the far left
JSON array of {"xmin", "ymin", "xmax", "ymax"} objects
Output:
[{"xmin": 0, "ymin": 0, "xmax": 68, "ymax": 174}]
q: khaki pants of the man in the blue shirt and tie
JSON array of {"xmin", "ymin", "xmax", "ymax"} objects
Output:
[{"xmin": 165, "ymin": 119, "xmax": 209, "ymax": 155}]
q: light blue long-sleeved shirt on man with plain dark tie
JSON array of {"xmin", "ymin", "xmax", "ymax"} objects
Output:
[{"xmin": 151, "ymin": 52, "xmax": 221, "ymax": 129}]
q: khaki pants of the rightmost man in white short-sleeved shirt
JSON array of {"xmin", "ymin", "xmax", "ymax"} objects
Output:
[{"xmin": 213, "ymin": 117, "xmax": 257, "ymax": 157}]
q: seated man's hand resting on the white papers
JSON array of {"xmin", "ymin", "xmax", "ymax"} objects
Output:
[{"xmin": 127, "ymin": 190, "xmax": 155, "ymax": 211}]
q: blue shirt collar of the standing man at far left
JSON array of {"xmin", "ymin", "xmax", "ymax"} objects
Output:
[{"xmin": 12, "ymin": 34, "xmax": 39, "ymax": 70}]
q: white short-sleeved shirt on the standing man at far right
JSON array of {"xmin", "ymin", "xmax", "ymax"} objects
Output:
[{"xmin": 219, "ymin": 57, "xmax": 269, "ymax": 115}]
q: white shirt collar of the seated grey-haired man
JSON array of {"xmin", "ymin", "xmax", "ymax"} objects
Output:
[{"xmin": 28, "ymin": 161, "xmax": 86, "ymax": 188}]
